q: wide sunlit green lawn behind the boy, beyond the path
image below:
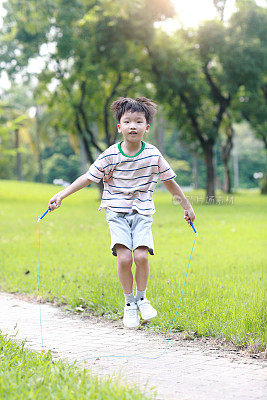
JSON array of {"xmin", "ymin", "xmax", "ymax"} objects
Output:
[{"xmin": 0, "ymin": 181, "xmax": 267, "ymax": 352}]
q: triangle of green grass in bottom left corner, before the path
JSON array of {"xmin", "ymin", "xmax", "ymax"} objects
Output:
[{"xmin": 0, "ymin": 333, "xmax": 155, "ymax": 400}]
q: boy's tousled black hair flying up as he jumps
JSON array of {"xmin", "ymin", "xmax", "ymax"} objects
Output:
[{"xmin": 110, "ymin": 97, "xmax": 157, "ymax": 124}]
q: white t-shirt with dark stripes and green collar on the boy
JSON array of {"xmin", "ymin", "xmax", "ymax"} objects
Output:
[{"xmin": 87, "ymin": 141, "xmax": 176, "ymax": 215}]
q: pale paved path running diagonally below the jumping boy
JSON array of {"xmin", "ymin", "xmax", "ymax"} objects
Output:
[{"xmin": 0, "ymin": 293, "xmax": 267, "ymax": 400}]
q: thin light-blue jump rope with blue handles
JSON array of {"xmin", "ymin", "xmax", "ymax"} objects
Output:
[{"xmin": 37, "ymin": 207, "xmax": 198, "ymax": 364}]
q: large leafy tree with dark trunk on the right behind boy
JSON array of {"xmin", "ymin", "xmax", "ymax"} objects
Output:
[{"xmin": 147, "ymin": 3, "xmax": 267, "ymax": 198}]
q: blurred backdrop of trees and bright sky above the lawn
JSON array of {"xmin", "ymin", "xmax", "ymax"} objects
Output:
[{"xmin": 0, "ymin": 0, "xmax": 267, "ymax": 198}]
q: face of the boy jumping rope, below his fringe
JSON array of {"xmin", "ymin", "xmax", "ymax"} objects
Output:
[{"xmin": 118, "ymin": 111, "xmax": 150, "ymax": 142}]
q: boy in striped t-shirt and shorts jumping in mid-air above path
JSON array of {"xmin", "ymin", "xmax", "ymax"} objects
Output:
[{"xmin": 49, "ymin": 97, "xmax": 195, "ymax": 328}]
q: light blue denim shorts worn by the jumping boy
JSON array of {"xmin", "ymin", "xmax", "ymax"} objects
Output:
[{"xmin": 106, "ymin": 208, "xmax": 154, "ymax": 256}]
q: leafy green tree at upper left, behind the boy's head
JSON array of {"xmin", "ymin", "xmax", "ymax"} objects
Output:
[{"xmin": 1, "ymin": 0, "xmax": 173, "ymax": 195}]
